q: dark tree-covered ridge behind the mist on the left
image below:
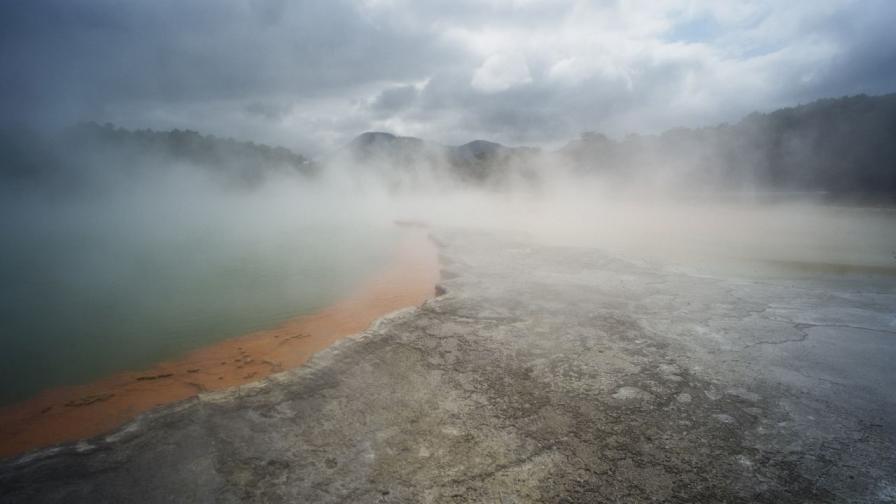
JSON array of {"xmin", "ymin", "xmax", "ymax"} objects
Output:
[{"xmin": 0, "ymin": 123, "xmax": 319, "ymax": 193}]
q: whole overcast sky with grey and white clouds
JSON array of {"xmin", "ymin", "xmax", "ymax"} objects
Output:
[{"xmin": 0, "ymin": 0, "xmax": 896, "ymax": 155}]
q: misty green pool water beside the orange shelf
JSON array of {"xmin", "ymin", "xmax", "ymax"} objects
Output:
[{"xmin": 0, "ymin": 198, "xmax": 396, "ymax": 403}]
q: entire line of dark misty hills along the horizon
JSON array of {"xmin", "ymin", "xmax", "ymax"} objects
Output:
[{"xmin": 7, "ymin": 94, "xmax": 896, "ymax": 202}]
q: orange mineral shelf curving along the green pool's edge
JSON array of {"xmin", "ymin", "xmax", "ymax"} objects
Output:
[{"xmin": 0, "ymin": 229, "xmax": 439, "ymax": 458}]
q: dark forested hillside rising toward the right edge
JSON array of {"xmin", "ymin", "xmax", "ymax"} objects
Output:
[{"xmin": 557, "ymin": 94, "xmax": 896, "ymax": 200}]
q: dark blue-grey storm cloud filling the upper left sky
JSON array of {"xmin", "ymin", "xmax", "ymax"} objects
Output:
[{"xmin": 0, "ymin": 0, "xmax": 458, "ymax": 130}]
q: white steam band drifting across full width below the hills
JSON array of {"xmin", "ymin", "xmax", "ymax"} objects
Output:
[{"xmin": 0, "ymin": 117, "xmax": 896, "ymax": 300}]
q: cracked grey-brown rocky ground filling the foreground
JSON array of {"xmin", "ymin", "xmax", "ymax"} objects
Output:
[{"xmin": 0, "ymin": 233, "xmax": 896, "ymax": 503}]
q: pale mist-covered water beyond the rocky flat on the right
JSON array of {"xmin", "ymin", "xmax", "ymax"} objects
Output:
[{"xmin": 354, "ymin": 165, "xmax": 896, "ymax": 275}]
